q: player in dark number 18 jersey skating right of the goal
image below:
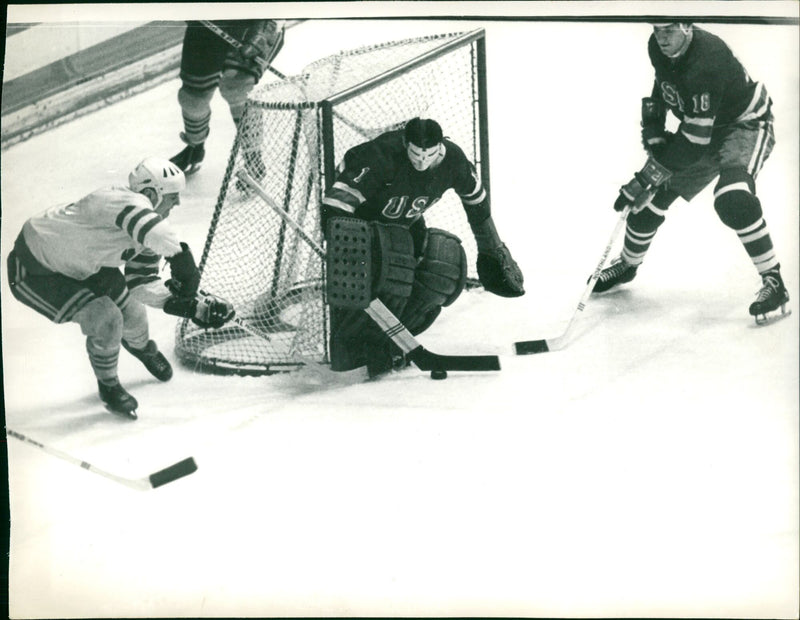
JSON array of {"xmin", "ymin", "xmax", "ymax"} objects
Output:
[{"xmin": 594, "ymin": 23, "xmax": 789, "ymax": 323}]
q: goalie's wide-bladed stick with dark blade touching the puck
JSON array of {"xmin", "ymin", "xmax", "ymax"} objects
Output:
[{"xmin": 236, "ymin": 170, "xmax": 500, "ymax": 371}]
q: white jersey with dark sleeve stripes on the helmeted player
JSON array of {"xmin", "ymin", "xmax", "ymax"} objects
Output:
[{"xmin": 22, "ymin": 187, "xmax": 181, "ymax": 280}]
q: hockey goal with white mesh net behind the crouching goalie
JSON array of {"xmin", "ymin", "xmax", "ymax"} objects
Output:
[{"xmin": 176, "ymin": 30, "xmax": 489, "ymax": 375}]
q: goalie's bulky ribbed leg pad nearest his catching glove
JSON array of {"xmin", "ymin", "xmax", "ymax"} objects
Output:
[{"xmin": 400, "ymin": 228, "xmax": 467, "ymax": 334}]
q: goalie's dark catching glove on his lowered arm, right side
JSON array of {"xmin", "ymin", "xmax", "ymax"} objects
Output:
[{"xmin": 470, "ymin": 216, "xmax": 525, "ymax": 297}]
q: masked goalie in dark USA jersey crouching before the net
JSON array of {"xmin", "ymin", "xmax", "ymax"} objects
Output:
[{"xmin": 322, "ymin": 118, "xmax": 525, "ymax": 376}]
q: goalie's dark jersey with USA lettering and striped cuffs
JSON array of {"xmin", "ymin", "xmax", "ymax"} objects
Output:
[{"xmin": 322, "ymin": 130, "xmax": 489, "ymax": 227}]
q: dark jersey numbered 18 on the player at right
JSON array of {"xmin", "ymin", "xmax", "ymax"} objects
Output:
[{"xmin": 647, "ymin": 27, "xmax": 772, "ymax": 170}]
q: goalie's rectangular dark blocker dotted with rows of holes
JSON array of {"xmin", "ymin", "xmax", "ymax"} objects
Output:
[{"xmin": 325, "ymin": 217, "xmax": 372, "ymax": 308}]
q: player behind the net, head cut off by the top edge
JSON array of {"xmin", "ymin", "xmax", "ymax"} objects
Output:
[{"xmin": 171, "ymin": 19, "xmax": 284, "ymax": 177}]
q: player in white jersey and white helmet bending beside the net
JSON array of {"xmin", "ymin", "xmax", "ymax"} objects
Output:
[{"xmin": 7, "ymin": 157, "xmax": 233, "ymax": 418}]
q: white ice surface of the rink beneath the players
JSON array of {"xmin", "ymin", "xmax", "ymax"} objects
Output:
[{"xmin": 2, "ymin": 10, "xmax": 800, "ymax": 618}]
